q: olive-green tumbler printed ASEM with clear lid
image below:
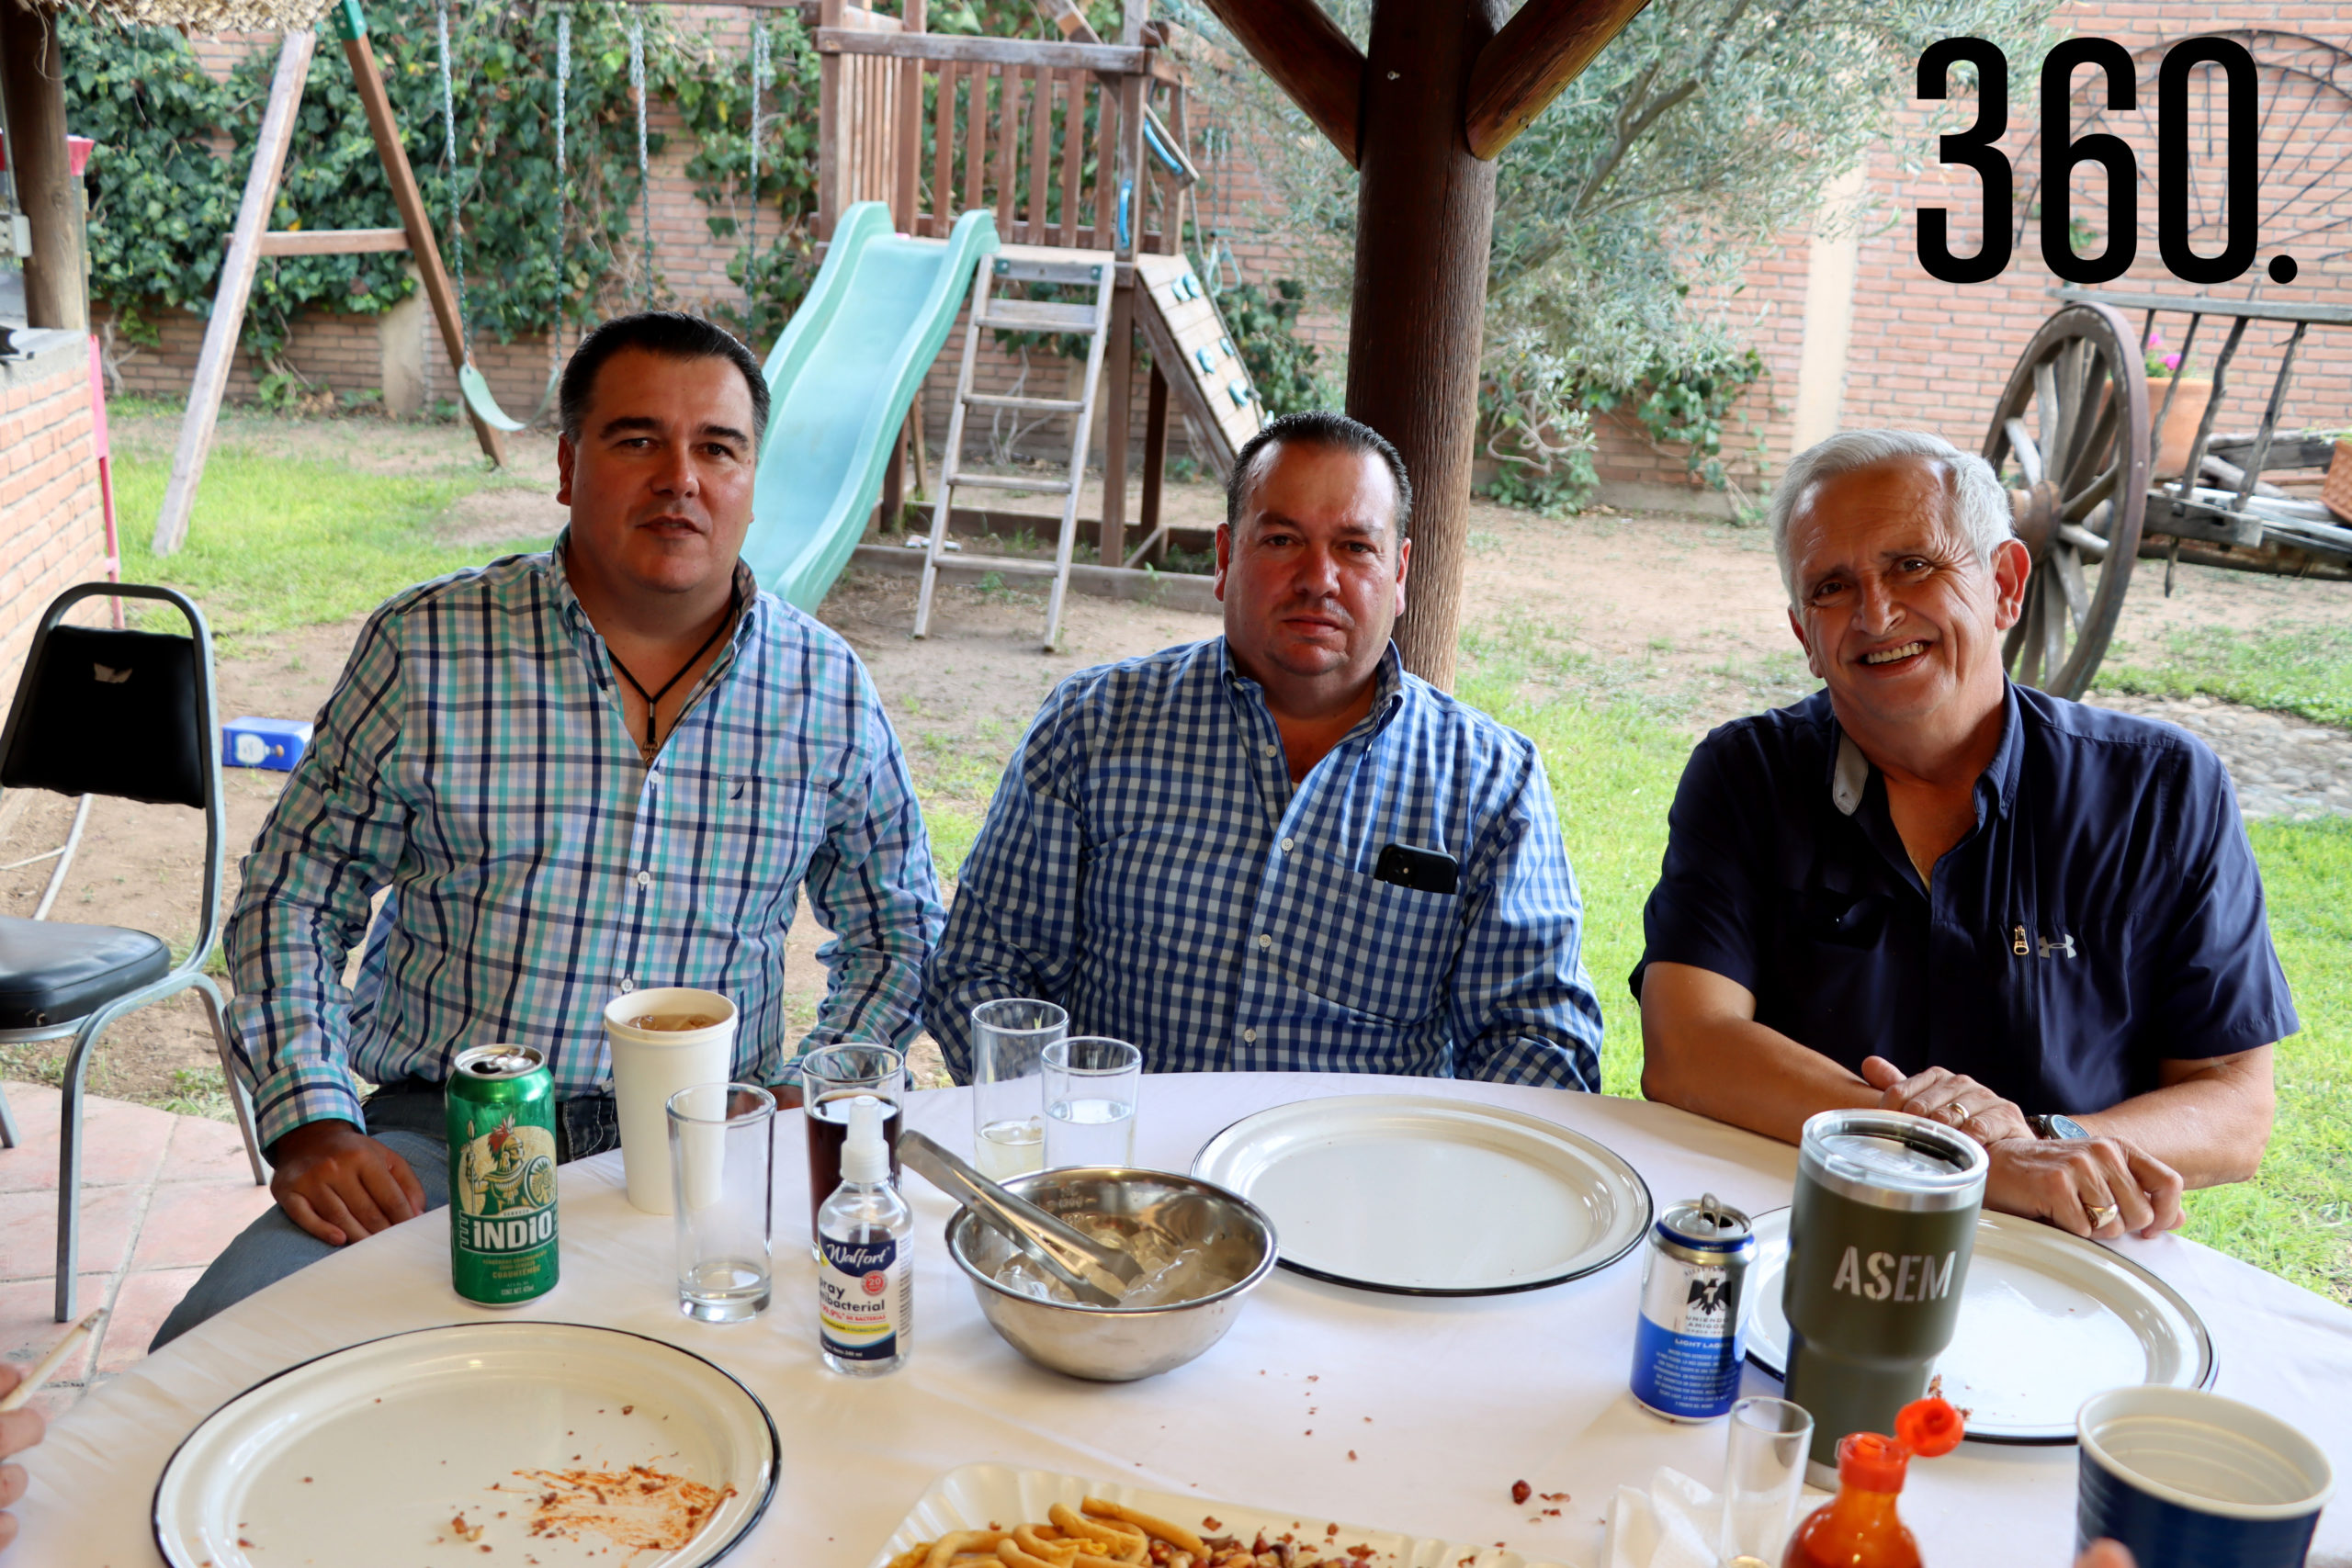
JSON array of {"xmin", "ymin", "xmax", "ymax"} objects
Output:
[{"xmin": 1781, "ymin": 1110, "xmax": 1992, "ymax": 1488}]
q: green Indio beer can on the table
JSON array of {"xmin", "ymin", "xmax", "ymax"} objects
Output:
[{"xmin": 447, "ymin": 1046, "xmax": 558, "ymax": 1307}]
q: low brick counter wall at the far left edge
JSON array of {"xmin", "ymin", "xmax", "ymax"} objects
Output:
[{"xmin": 0, "ymin": 332, "xmax": 106, "ymax": 703}]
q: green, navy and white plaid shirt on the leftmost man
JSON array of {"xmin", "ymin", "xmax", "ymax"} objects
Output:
[{"xmin": 228, "ymin": 541, "xmax": 941, "ymax": 1143}]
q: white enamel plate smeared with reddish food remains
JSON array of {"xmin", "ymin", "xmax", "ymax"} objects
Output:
[{"xmin": 155, "ymin": 1324, "xmax": 778, "ymax": 1568}]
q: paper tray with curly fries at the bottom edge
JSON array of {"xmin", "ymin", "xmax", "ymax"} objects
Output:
[{"xmin": 870, "ymin": 1464, "xmax": 1559, "ymax": 1568}]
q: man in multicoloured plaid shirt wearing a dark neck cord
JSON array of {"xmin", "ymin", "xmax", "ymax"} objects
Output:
[{"xmin": 158, "ymin": 312, "xmax": 941, "ymax": 1345}]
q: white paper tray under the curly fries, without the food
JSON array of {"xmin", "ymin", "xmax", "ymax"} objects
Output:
[{"xmin": 873, "ymin": 1464, "xmax": 1559, "ymax": 1568}]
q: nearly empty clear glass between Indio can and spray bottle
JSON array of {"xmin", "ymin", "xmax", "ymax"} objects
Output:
[{"xmin": 668, "ymin": 1084, "xmax": 776, "ymax": 1324}]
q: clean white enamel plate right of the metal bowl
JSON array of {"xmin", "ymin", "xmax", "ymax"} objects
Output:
[{"xmin": 1193, "ymin": 1096, "xmax": 1651, "ymax": 1295}]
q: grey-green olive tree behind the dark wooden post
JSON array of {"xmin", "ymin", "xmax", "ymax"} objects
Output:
[{"xmin": 1173, "ymin": 0, "xmax": 2055, "ymax": 508}]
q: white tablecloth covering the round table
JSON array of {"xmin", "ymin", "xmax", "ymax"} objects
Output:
[{"xmin": 9, "ymin": 1075, "xmax": 2352, "ymax": 1568}]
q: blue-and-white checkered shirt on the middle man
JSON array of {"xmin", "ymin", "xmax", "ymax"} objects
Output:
[{"xmin": 924, "ymin": 637, "xmax": 1601, "ymax": 1089}]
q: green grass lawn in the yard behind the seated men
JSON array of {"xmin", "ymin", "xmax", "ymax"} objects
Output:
[{"xmin": 78, "ymin": 423, "xmax": 2352, "ymax": 1303}]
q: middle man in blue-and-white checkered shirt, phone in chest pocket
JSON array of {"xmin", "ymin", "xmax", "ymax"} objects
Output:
[{"xmin": 924, "ymin": 413, "xmax": 1601, "ymax": 1089}]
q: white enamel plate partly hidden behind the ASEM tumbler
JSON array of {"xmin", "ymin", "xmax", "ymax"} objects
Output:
[{"xmin": 1747, "ymin": 1208, "xmax": 2213, "ymax": 1443}]
